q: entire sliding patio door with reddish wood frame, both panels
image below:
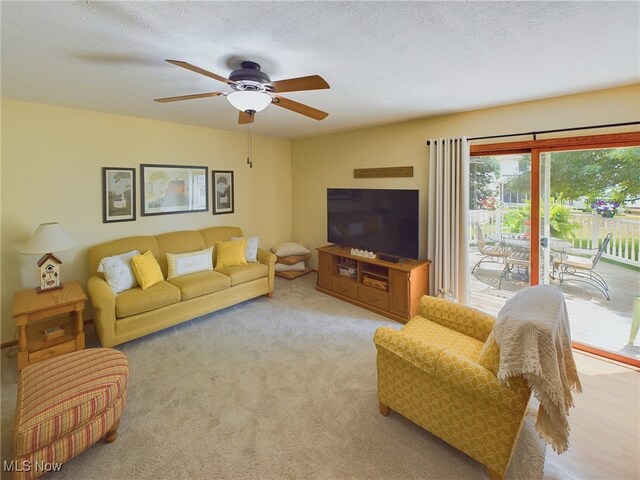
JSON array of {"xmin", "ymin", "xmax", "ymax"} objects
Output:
[{"xmin": 469, "ymin": 134, "xmax": 640, "ymax": 366}]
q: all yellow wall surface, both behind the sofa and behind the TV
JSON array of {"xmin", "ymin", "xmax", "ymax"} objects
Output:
[{"xmin": 0, "ymin": 85, "xmax": 640, "ymax": 343}]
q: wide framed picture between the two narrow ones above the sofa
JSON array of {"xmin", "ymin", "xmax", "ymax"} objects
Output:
[{"xmin": 140, "ymin": 164, "xmax": 209, "ymax": 216}]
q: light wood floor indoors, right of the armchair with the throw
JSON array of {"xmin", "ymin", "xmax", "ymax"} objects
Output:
[{"xmin": 543, "ymin": 350, "xmax": 640, "ymax": 480}]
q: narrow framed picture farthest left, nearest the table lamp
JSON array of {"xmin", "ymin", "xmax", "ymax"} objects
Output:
[{"xmin": 102, "ymin": 167, "xmax": 136, "ymax": 223}]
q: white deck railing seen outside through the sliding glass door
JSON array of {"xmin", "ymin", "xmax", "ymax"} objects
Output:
[{"xmin": 469, "ymin": 210, "xmax": 640, "ymax": 267}]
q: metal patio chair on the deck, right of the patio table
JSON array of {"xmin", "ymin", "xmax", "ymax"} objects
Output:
[{"xmin": 552, "ymin": 233, "xmax": 613, "ymax": 300}]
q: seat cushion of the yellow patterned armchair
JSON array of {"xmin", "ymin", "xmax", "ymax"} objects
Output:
[{"xmin": 402, "ymin": 317, "xmax": 484, "ymax": 361}]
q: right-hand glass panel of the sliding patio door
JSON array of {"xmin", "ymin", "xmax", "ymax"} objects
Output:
[{"xmin": 540, "ymin": 147, "xmax": 640, "ymax": 360}]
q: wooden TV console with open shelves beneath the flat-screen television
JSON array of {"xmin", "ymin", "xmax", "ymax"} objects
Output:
[{"xmin": 316, "ymin": 245, "xmax": 431, "ymax": 323}]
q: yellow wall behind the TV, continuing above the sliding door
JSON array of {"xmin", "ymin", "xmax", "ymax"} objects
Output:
[{"xmin": 292, "ymin": 85, "xmax": 640, "ymax": 266}]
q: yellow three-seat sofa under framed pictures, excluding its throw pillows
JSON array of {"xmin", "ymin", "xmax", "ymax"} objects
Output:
[{"xmin": 87, "ymin": 227, "xmax": 277, "ymax": 347}]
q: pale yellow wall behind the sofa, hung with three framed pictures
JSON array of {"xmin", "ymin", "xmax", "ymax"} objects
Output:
[{"xmin": 0, "ymin": 100, "xmax": 292, "ymax": 343}]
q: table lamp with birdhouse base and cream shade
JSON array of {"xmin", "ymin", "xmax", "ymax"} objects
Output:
[{"xmin": 20, "ymin": 222, "xmax": 78, "ymax": 293}]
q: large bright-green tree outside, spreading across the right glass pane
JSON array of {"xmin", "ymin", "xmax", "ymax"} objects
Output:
[{"xmin": 507, "ymin": 147, "xmax": 640, "ymax": 203}]
